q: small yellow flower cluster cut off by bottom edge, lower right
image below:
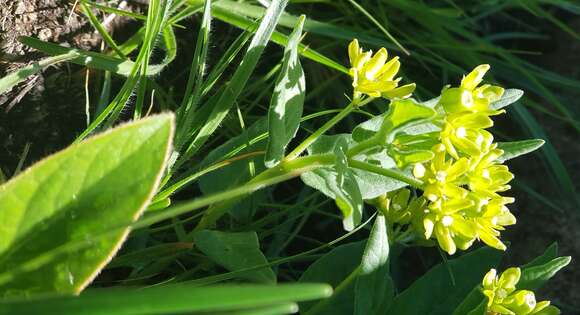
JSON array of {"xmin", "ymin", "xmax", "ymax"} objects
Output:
[{"xmin": 482, "ymin": 268, "xmax": 560, "ymax": 315}]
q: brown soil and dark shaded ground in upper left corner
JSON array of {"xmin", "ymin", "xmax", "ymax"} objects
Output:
[{"xmin": 0, "ymin": 0, "xmax": 133, "ymax": 175}]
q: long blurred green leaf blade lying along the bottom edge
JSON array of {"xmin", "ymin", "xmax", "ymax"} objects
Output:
[{"xmin": 0, "ymin": 283, "xmax": 332, "ymax": 315}]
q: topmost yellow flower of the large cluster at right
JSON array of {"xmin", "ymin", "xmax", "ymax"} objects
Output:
[{"xmin": 439, "ymin": 65, "xmax": 504, "ymax": 115}]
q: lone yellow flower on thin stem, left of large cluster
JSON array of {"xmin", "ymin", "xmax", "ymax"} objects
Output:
[{"xmin": 348, "ymin": 39, "xmax": 415, "ymax": 99}]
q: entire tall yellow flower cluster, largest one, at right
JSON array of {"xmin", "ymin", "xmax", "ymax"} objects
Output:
[{"xmin": 413, "ymin": 65, "xmax": 516, "ymax": 255}]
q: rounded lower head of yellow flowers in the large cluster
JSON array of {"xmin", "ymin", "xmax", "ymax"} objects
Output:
[{"xmin": 413, "ymin": 144, "xmax": 516, "ymax": 255}]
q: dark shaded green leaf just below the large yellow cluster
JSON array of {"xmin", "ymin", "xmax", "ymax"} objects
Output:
[{"xmin": 387, "ymin": 247, "xmax": 501, "ymax": 315}]
